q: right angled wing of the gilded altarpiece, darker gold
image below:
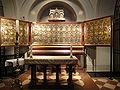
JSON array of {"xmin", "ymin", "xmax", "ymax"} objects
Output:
[{"xmin": 84, "ymin": 17, "xmax": 111, "ymax": 45}]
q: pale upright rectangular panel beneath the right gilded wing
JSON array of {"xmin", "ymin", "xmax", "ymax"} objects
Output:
[{"xmin": 96, "ymin": 47, "xmax": 110, "ymax": 71}]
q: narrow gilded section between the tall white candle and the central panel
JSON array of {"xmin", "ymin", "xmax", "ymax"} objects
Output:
[{"xmin": 19, "ymin": 21, "xmax": 28, "ymax": 45}]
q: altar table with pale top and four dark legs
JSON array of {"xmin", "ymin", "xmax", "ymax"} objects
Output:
[{"xmin": 24, "ymin": 56, "xmax": 78, "ymax": 86}]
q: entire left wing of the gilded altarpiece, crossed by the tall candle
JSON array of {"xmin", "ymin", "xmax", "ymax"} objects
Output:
[{"xmin": 0, "ymin": 17, "xmax": 31, "ymax": 46}]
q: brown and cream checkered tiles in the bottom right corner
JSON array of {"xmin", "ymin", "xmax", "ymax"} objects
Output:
[{"xmin": 93, "ymin": 77, "xmax": 120, "ymax": 90}]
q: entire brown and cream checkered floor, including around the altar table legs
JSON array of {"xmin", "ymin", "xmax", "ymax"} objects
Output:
[{"xmin": 0, "ymin": 70, "xmax": 120, "ymax": 90}]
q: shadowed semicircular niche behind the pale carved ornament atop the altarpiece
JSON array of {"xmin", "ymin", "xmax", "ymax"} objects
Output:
[{"xmin": 37, "ymin": 1, "xmax": 77, "ymax": 21}]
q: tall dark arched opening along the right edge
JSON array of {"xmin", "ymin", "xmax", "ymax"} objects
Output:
[{"xmin": 113, "ymin": 0, "xmax": 120, "ymax": 77}]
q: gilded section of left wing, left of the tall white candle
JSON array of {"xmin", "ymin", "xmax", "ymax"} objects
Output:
[{"xmin": 1, "ymin": 18, "xmax": 16, "ymax": 46}]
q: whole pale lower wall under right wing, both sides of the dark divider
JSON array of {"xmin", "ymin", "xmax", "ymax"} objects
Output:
[{"xmin": 87, "ymin": 46, "xmax": 110, "ymax": 72}]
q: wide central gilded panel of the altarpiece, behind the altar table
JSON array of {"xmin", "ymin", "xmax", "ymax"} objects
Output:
[{"xmin": 32, "ymin": 23, "xmax": 82, "ymax": 45}]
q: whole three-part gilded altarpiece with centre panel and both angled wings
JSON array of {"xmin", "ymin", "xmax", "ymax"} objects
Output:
[{"xmin": 0, "ymin": 16, "xmax": 112, "ymax": 46}]
